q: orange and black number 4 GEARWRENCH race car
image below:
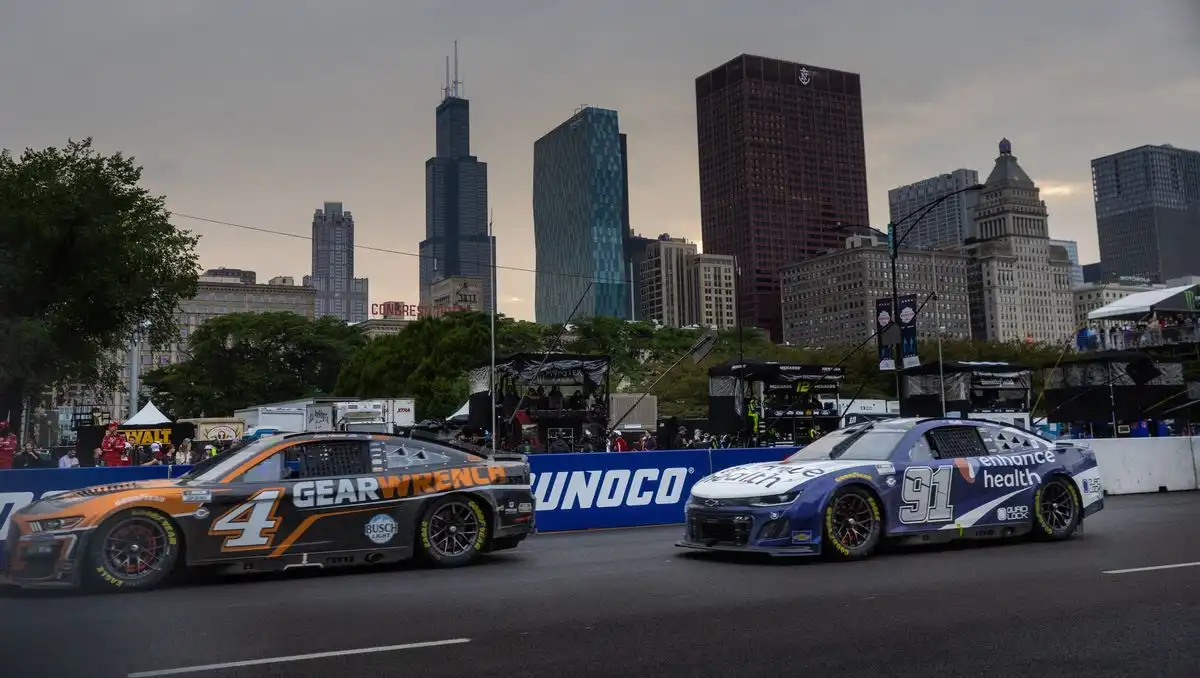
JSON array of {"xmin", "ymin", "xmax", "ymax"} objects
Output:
[{"xmin": 0, "ymin": 433, "xmax": 534, "ymax": 590}]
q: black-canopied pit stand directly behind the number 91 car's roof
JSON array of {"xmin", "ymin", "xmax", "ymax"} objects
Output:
[{"xmin": 900, "ymin": 361, "xmax": 1033, "ymax": 428}]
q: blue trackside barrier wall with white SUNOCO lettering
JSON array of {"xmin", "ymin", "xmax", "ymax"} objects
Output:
[{"xmin": 0, "ymin": 448, "xmax": 796, "ymax": 553}]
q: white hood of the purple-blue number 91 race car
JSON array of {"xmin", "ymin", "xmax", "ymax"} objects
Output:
[{"xmin": 691, "ymin": 460, "xmax": 890, "ymax": 499}]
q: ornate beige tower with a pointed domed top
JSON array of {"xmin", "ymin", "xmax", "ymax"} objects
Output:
[{"xmin": 965, "ymin": 139, "xmax": 1076, "ymax": 343}]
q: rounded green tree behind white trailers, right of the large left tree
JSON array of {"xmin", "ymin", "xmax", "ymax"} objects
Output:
[{"xmin": 145, "ymin": 312, "xmax": 366, "ymax": 416}]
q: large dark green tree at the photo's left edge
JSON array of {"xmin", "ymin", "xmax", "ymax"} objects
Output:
[{"xmin": 0, "ymin": 138, "xmax": 198, "ymax": 420}]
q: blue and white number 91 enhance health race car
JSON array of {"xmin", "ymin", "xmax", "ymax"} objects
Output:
[{"xmin": 677, "ymin": 419, "xmax": 1104, "ymax": 559}]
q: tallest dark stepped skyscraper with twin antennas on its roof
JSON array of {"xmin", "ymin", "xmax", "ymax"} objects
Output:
[{"xmin": 420, "ymin": 42, "xmax": 496, "ymax": 313}]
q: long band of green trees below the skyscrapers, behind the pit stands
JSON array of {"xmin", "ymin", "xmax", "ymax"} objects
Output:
[{"xmin": 148, "ymin": 313, "xmax": 1080, "ymax": 418}]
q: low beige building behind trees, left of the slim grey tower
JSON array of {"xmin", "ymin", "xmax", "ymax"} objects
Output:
[{"xmin": 112, "ymin": 271, "xmax": 317, "ymax": 420}]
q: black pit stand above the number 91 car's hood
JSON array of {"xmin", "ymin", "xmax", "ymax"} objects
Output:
[{"xmin": 708, "ymin": 360, "xmax": 846, "ymax": 444}]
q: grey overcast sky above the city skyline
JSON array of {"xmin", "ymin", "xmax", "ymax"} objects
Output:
[{"xmin": 0, "ymin": 0, "xmax": 1200, "ymax": 318}]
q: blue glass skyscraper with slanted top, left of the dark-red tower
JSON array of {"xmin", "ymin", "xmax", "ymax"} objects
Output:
[{"xmin": 533, "ymin": 107, "xmax": 630, "ymax": 323}]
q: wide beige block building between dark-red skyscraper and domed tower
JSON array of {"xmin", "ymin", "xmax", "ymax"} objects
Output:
[{"xmin": 780, "ymin": 234, "xmax": 971, "ymax": 347}]
